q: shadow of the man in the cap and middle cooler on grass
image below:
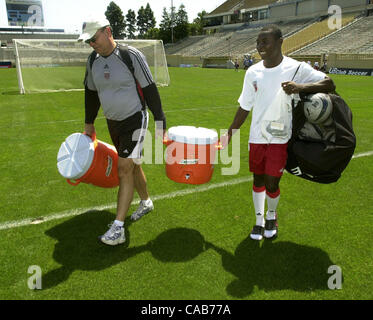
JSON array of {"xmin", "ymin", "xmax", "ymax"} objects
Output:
[{"xmin": 42, "ymin": 211, "xmax": 204, "ymax": 289}]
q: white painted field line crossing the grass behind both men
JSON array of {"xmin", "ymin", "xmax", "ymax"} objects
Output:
[{"xmin": 0, "ymin": 151, "xmax": 373, "ymax": 230}]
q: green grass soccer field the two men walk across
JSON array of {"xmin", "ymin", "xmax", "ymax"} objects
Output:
[{"xmin": 0, "ymin": 68, "xmax": 373, "ymax": 300}]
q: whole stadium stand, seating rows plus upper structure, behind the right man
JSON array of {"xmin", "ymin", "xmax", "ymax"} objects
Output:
[{"xmin": 166, "ymin": 0, "xmax": 373, "ymax": 64}]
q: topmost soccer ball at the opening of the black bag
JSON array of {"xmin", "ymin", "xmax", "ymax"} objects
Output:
[{"xmin": 304, "ymin": 93, "xmax": 333, "ymax": 124}]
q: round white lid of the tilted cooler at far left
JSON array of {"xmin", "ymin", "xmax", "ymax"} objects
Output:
[{"xmin": 57, "ymin": 133, "xmax": 95, "ymax": 179}]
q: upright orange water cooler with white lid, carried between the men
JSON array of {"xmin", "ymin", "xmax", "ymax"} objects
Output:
[{"xmin": 165, "ymin": 126, "xmax": 220, "ymax": 184}]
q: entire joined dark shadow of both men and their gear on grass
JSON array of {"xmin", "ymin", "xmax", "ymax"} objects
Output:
[{"xmin": 42, "ymin": 211, "xmax": 334, "ymax": 298}]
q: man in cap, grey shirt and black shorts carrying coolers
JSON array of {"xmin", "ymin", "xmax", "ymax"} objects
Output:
[{"xmin": 79, "ymin": 21, "xmax": 166, "ymax": 245}]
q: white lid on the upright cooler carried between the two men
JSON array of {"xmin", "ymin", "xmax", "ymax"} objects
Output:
[{"xmin": 167, "ymin": 126, "xmax": 218, "ymax": 145}]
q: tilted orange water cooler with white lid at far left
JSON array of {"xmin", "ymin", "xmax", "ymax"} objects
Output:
[{"xmin": 57, "ymin": 133, "xmax": 119, "ymax": 188}]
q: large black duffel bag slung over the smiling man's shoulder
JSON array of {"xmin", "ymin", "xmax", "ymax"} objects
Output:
[{"xmin": 286, "ymin": 94, "xmax": 356, "ymax": 183}]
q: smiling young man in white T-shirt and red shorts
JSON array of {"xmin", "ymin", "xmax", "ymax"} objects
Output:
[{"xmin": 221, "ymin": 25, "xmax": 335, "ymax": 240}]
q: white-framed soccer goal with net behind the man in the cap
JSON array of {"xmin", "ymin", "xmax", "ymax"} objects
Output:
[{"xmin": 13, "ymin": 39, "xmax": 170, "ymax": 94}]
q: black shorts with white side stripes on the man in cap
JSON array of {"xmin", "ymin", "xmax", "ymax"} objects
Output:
[{"xmin": 106, "ymin": 111, "xmax": 149, "ymax": 159}]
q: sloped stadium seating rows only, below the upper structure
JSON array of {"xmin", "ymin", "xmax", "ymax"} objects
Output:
[{"xmin": 166, "ymin": 13, "xmax": 373, "ymax": 57}]
